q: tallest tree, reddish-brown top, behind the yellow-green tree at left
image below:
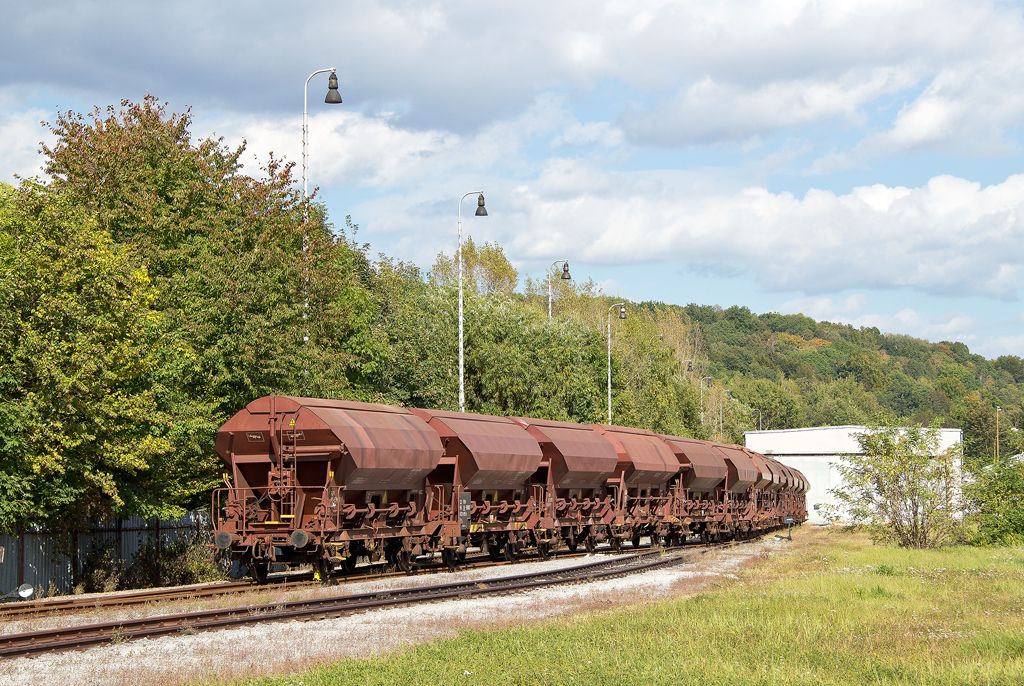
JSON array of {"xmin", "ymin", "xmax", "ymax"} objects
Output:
[{"xmin": 0, "ymin": 97, "xmax": 382, "ymax": 532}]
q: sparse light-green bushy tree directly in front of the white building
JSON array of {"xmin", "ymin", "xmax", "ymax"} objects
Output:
[{"xmin": 829, "ymin": 426, "xmax": 963, "ymax": 548}]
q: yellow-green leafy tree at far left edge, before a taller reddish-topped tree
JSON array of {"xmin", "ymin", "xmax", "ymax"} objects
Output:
[{"xmin": 0, "ymin": 185, "xmax": 173, "ymax": 530}]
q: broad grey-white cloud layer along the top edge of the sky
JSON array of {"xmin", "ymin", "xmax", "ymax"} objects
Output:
[{"xmin": 6, "ymin": 0, "xmax": 1024, "ymax": 145}]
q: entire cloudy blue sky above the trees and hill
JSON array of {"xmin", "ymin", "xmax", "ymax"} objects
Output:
[{"xmin": 6, "ymin": 0, "xmax": 1024, "ymax": 356}]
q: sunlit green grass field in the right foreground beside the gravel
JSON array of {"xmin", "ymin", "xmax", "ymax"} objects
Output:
[{"xmin": 220, "ymin": 527, "xmax": 1024, "ymax": 686}]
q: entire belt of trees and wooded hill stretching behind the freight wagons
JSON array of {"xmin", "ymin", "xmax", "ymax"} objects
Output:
[{"xmin": 0, "ymin": 98, "xmax": 1024, "ymax": 530}]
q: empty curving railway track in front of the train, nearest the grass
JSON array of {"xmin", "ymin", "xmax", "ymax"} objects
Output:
[{"xmin": 0, "ymin": 544, "xmax": 735, "ymax": 657}]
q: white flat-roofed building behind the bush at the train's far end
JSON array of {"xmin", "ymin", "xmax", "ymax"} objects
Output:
[{"xmin": 743, "ymin": 426, "xmax": 964, "ymax": 524}]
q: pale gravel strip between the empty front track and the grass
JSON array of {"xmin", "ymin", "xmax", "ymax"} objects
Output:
[{"xmin": 0, "ymin": 538, "xmax": 785, "ymax": 686}]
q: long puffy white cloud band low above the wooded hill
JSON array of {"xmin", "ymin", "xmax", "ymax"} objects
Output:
[{"xmin": 344, "ymin": 149, "xmax": 1024, "ymax": 299}]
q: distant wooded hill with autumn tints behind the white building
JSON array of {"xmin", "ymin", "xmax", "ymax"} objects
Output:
[{"xmin": 685, "ymin": 305, "xmax": 1024, "ymax": 460}]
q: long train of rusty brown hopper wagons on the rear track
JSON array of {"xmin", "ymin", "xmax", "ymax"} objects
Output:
[{"xmin": 212, "ymin": 395, "xmax": 808, "ymax": 582}]
